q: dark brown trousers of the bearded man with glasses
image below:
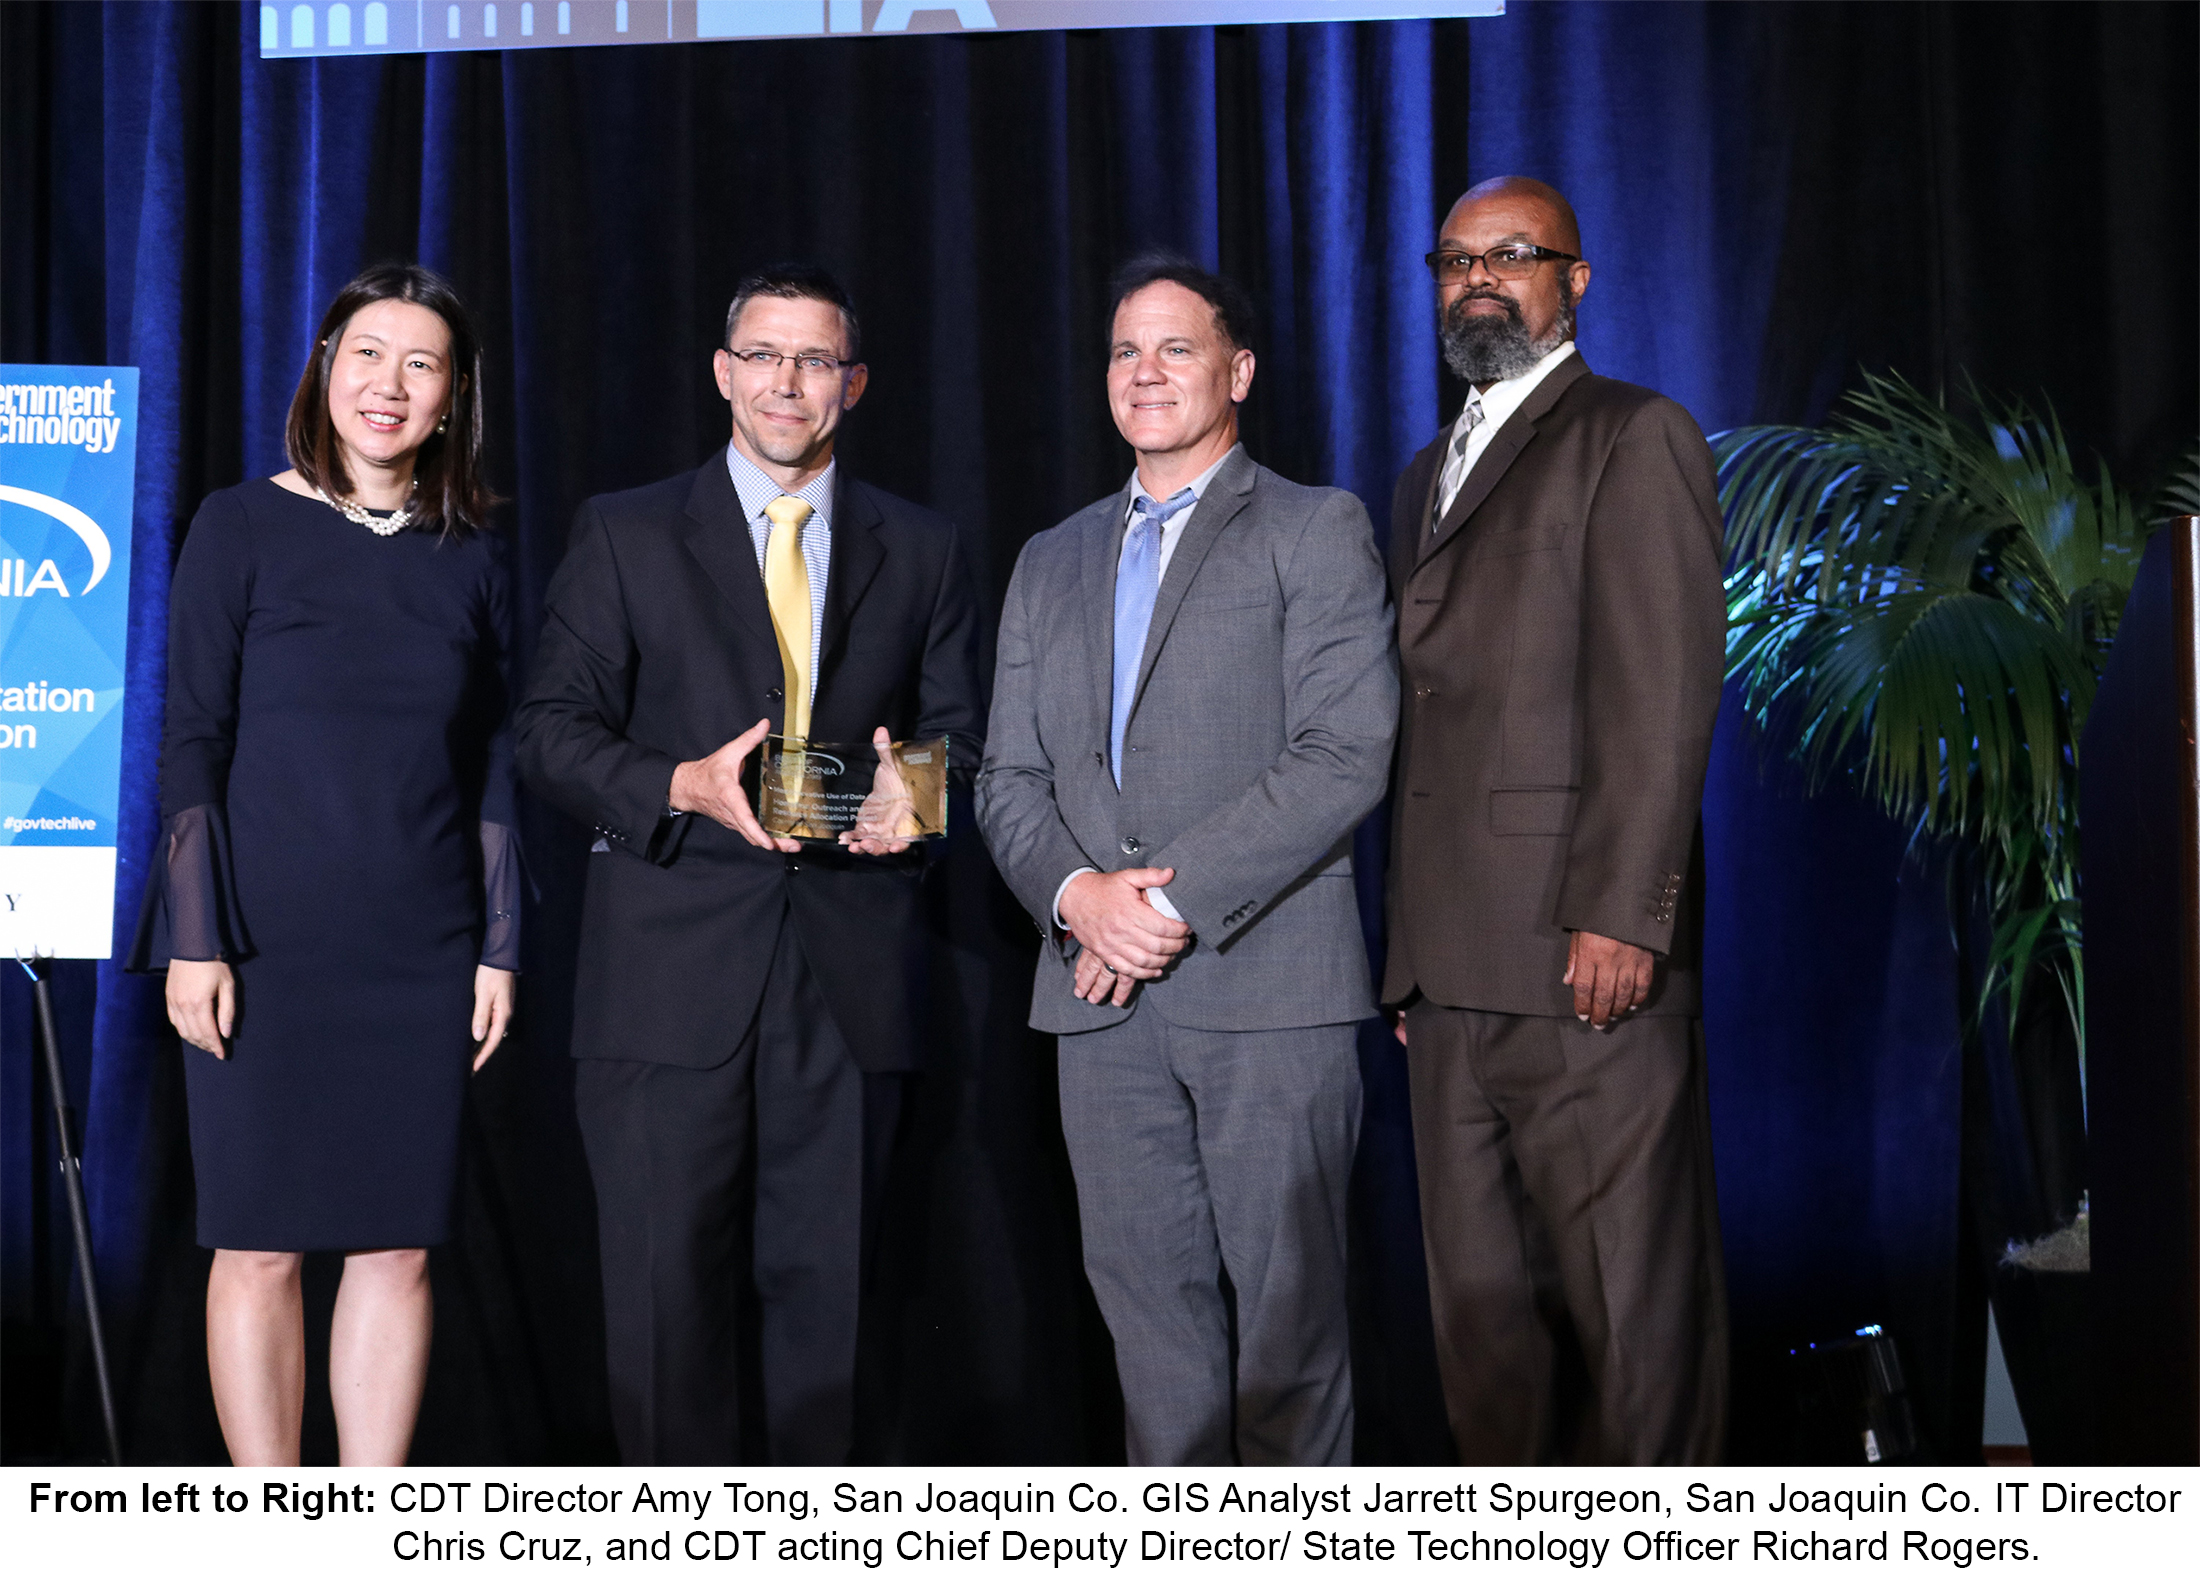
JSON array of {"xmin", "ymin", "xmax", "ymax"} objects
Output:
[{"xmin": 1406, "ymin": 1001, "xmax": 1727, "ymax": 1463}]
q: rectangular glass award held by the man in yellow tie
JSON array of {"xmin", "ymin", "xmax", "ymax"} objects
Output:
[{"xmin": 755, "ymin": 737, "xmax": 948, "ymax": 845}]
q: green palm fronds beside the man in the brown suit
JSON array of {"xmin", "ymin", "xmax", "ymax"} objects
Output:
[{"xmin": 1712, "ymin": 374, "xmax": 2145, "ymax": 1071}]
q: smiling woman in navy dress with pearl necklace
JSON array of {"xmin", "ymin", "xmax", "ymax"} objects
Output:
[{"xmin": 132, "ymin": 266, "xmax": 519, "ymax": 1465}]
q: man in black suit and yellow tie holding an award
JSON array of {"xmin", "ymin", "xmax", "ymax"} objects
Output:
[{"xmin": 517, "ymin": 266, "xmax": 983, "ymax": 1463}]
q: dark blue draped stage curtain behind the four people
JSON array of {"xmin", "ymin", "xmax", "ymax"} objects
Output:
[{"xmin": 0, "ymin": 0, "xmax": 2200, "ymax": 1463}]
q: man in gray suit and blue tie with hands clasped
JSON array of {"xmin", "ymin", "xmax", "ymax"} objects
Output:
[{"xmin": 977, "ymin": 255, "xmax": 1397, "ymax": 1465}]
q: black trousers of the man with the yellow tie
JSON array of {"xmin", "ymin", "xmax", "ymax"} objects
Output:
[{"xmin": 574, "ymin": 920, "xmax": 906, "ymax": 1463}]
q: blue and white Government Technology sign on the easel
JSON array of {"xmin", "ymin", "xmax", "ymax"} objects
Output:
[{"xmin": 0, "ymin": 363, "xmax": 136, "ymax": 957}]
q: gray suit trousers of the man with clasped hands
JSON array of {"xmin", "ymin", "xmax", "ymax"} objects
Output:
[{"xmin": 1060, "ymin": 1005, "xmax": 1360, "ymax": 1465}]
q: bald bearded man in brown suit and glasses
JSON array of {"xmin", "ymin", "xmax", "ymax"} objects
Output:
[{"xmin": 1382, "ymin": 176, "xmax": 1727, "ymax": 1463}]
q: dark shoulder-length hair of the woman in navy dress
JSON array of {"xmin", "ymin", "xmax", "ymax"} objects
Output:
[{"xmin": 282, "ymin": 264, "xmax": 502, "ymax": 535}]
